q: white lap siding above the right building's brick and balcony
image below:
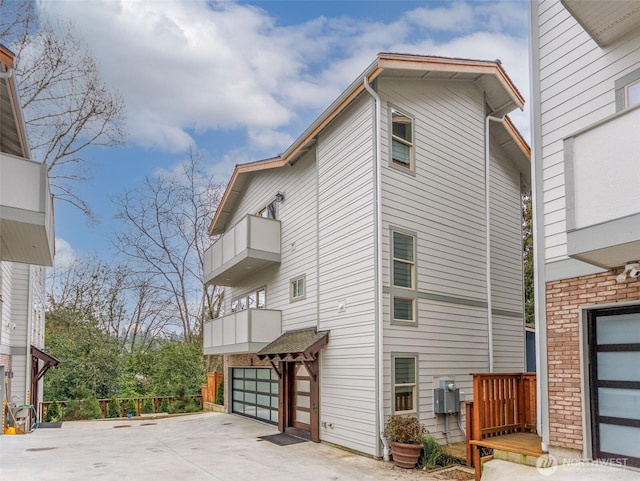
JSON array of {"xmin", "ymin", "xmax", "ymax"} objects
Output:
[{"xmin": 534, "ymin": 0, "xmax": 640, "ymax": 262}]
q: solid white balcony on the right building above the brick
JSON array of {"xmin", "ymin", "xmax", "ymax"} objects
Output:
[{"xmin": 564, "ymin": 107, "xmax": 640, "ymax": 269}]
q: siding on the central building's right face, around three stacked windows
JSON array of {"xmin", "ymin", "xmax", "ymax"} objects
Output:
[{"xmin": 379, "ymin": 80, "xmax": 524, "ymax": 441}]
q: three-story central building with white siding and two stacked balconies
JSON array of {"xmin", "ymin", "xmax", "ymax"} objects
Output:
[{"xmin": 203, "ymin": 53, "xmax": 530, "ymax": 457}]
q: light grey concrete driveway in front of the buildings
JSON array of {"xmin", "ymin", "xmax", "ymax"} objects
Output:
[{"xmin": 0, "ymin": 413, "xmax": 470, "ymax": 481}]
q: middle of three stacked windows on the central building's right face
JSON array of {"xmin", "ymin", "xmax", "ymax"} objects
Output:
[{"xmin": 391, "ymin": 231, "xmax": 417, "ymax": 322}]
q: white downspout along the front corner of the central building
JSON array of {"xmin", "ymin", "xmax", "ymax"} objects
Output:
[{"xmin": 363, "ymin": 75, "xmax": 391, "ymax": 461}]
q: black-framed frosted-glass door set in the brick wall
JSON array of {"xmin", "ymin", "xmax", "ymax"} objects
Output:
[{"xmin": 588, "ymin": 306, "xmax": 640, "ymax": 467}]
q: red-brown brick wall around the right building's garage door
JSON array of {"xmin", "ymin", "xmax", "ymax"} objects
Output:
[{"xmin": 546, "ymin": 269, "xmax": 640, "ymax": 450}]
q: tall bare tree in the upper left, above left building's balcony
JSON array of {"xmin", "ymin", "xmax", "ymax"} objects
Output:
[{"xmin": 0, "ymin": 0, "xmax": 125, "ymax": 218}]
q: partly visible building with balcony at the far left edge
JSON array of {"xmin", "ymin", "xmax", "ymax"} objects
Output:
[{"xmin": 0, "ymin": 45, "xmax": 57, "ymax": 432}]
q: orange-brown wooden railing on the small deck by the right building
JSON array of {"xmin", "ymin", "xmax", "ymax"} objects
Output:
[{"xmin": 466, "ymin": 372, "xmax": 536, "ymax": 470}]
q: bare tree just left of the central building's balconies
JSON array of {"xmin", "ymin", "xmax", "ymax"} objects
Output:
[{"xmin": 114, "ymin": 152, "xmax": 222, "ymax": 342}]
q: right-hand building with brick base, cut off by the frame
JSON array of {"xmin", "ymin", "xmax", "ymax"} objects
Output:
[{"xmin": 530, "ymin": 0, "xmax": 640, "ymax": 466}]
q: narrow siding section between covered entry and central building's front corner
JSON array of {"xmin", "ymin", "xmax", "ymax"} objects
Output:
[{"xmin": 317, "ymin": 95, "xmax": 378, "ymax": 455}]
